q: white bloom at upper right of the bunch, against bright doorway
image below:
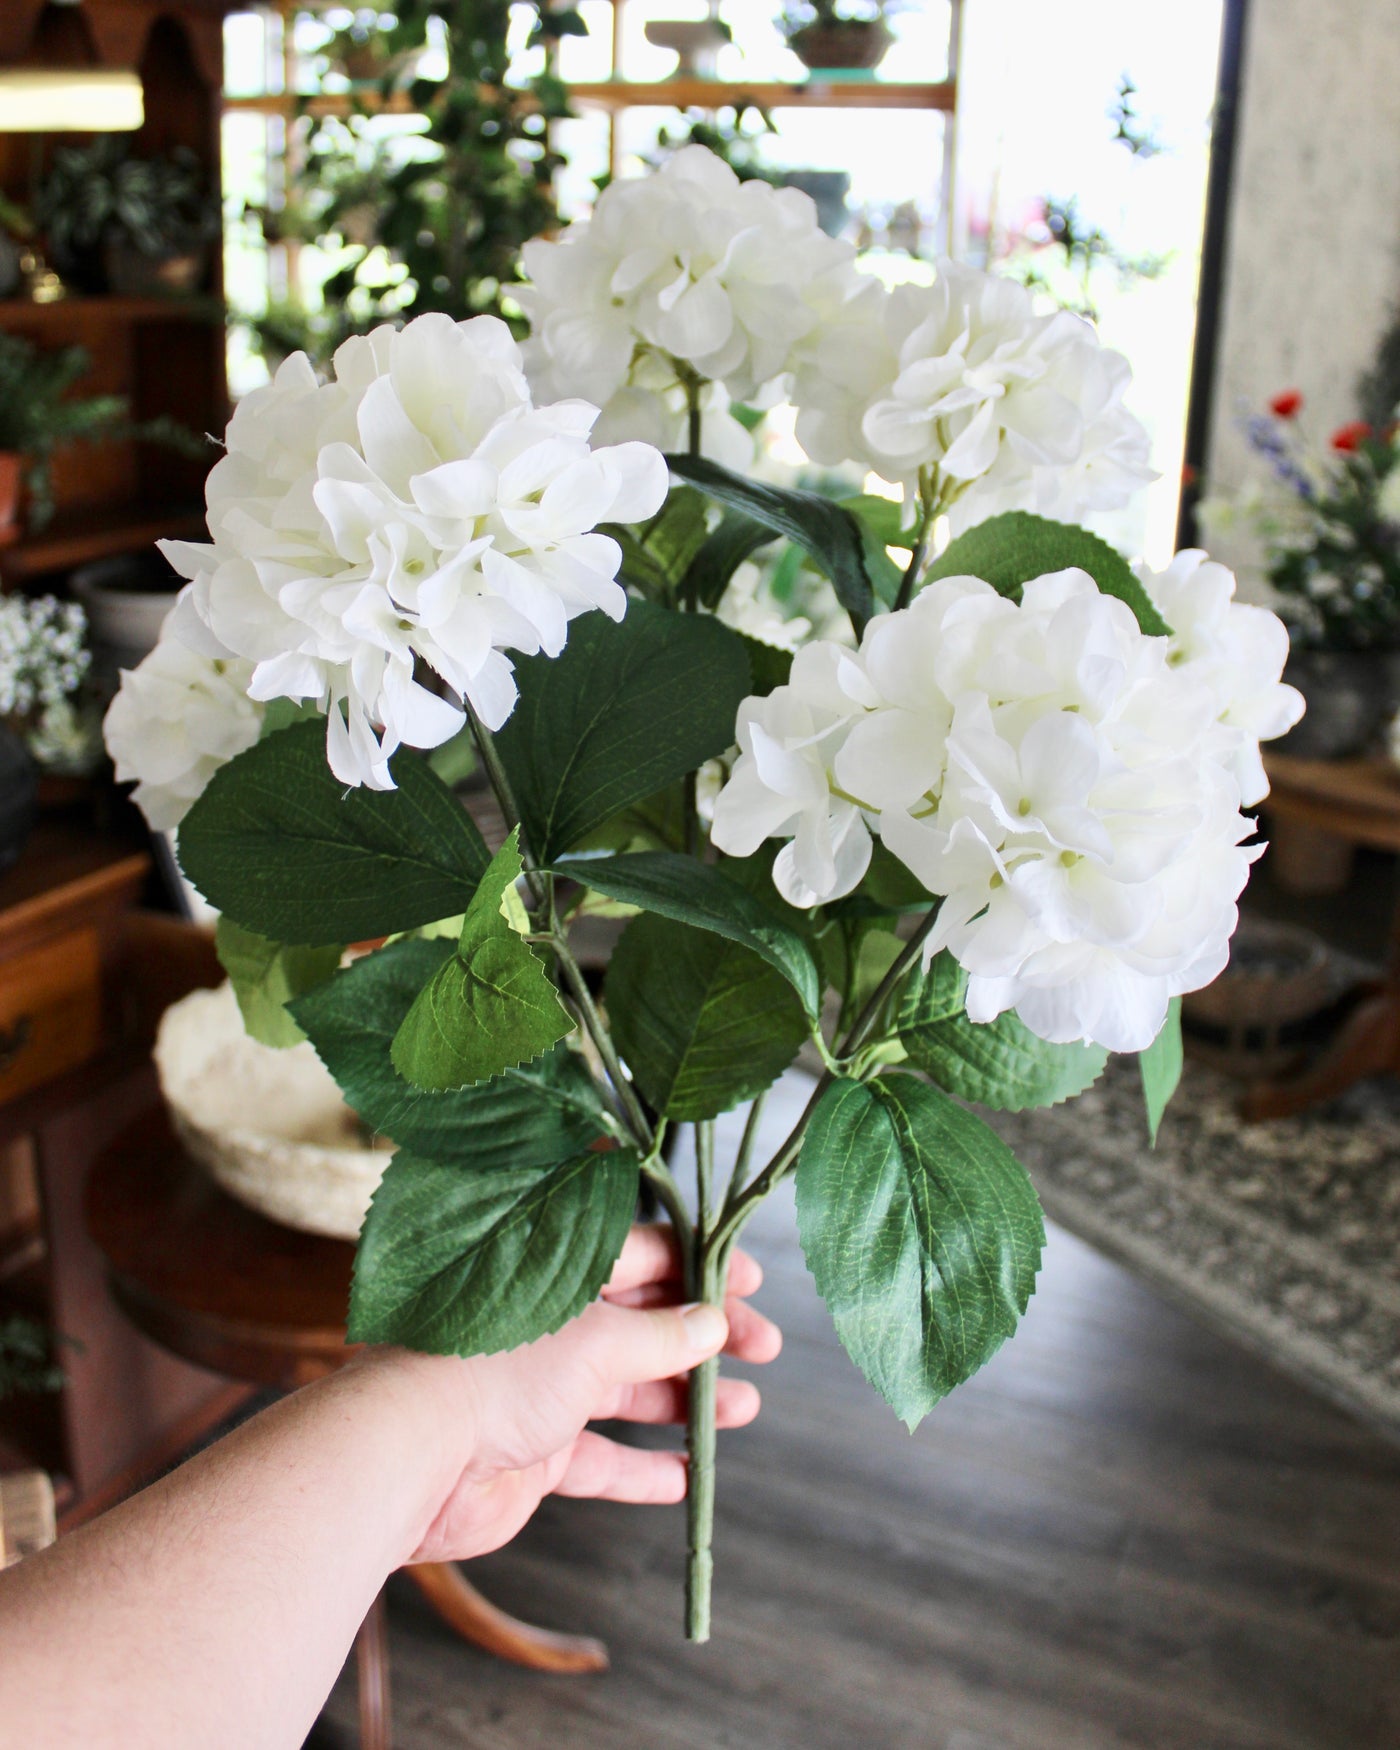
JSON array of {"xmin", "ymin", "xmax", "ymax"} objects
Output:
[{"xmin": 795, "ymin": 261, "xmax": 1157, "ymax": 534}]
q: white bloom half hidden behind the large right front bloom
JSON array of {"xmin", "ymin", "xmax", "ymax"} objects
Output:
[{"xmin": 1134, "ymin": 548, "xmax": 1306, "ymax": 809}]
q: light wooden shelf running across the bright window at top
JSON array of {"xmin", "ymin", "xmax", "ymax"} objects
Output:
[{"xmin": 224, "ymin": 74, "xmax": 957, "ymax": 116}]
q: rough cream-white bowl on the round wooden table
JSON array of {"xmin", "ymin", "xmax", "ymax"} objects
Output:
[{"xmin": 156, "ymin": 984, "xmax": 392, "ymax": 1239}]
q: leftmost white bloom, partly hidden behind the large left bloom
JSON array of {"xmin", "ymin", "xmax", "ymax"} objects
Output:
[{"xmin": 102, "ymin": 585, "xmax": 266, "ymax": 831}]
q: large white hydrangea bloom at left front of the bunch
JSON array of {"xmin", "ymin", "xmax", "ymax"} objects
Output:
[{"xmin": 161, "ymin": 315, "xmax": 667, "ymax": 789}]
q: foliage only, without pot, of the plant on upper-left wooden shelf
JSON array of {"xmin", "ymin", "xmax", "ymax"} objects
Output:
[{"xmin": 35, "ymin": 133, "xmax": 221, "ymax": 271}]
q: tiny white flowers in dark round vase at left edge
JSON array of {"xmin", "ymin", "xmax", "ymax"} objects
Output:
[{"xmin": 0, "ymin": 595, "xmax": 91, "ymax": 870}]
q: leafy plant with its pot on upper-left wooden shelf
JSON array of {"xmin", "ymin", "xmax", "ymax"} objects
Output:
[{"xmin": 35, "ymin": 135, "xmax": 221, "ymax": 298}]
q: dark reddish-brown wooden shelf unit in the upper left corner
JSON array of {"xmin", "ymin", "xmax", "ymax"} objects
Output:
[{"xmin": 0, "ymin": 0, "xmax": 233, "ymax": 586}]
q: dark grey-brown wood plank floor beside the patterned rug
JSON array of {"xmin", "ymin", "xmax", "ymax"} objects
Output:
[{"xmin": 315, "ymin": 1176, "xmax": 1400, "ymax": 1750}]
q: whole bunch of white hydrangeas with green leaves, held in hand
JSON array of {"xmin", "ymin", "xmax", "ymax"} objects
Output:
[{"xmin": 109, "ymin": 149, "xmax": 1300, "ymax": 1640}]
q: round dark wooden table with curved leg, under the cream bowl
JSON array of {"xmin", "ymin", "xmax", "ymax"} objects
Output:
[{"xmin": 88, "ymin": 1108, "xmax": 607, "ymax": 1750}]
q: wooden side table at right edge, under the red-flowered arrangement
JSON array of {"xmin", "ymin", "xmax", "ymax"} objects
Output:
[{"xmin": 1241, "ymin": 754, "xmax": 1400, "ymax": 1118}]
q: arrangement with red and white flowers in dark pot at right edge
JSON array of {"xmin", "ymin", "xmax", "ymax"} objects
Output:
[{"xmin": 1201, "ymin": 389, "xmax": 1400, "ymax": 760}]
